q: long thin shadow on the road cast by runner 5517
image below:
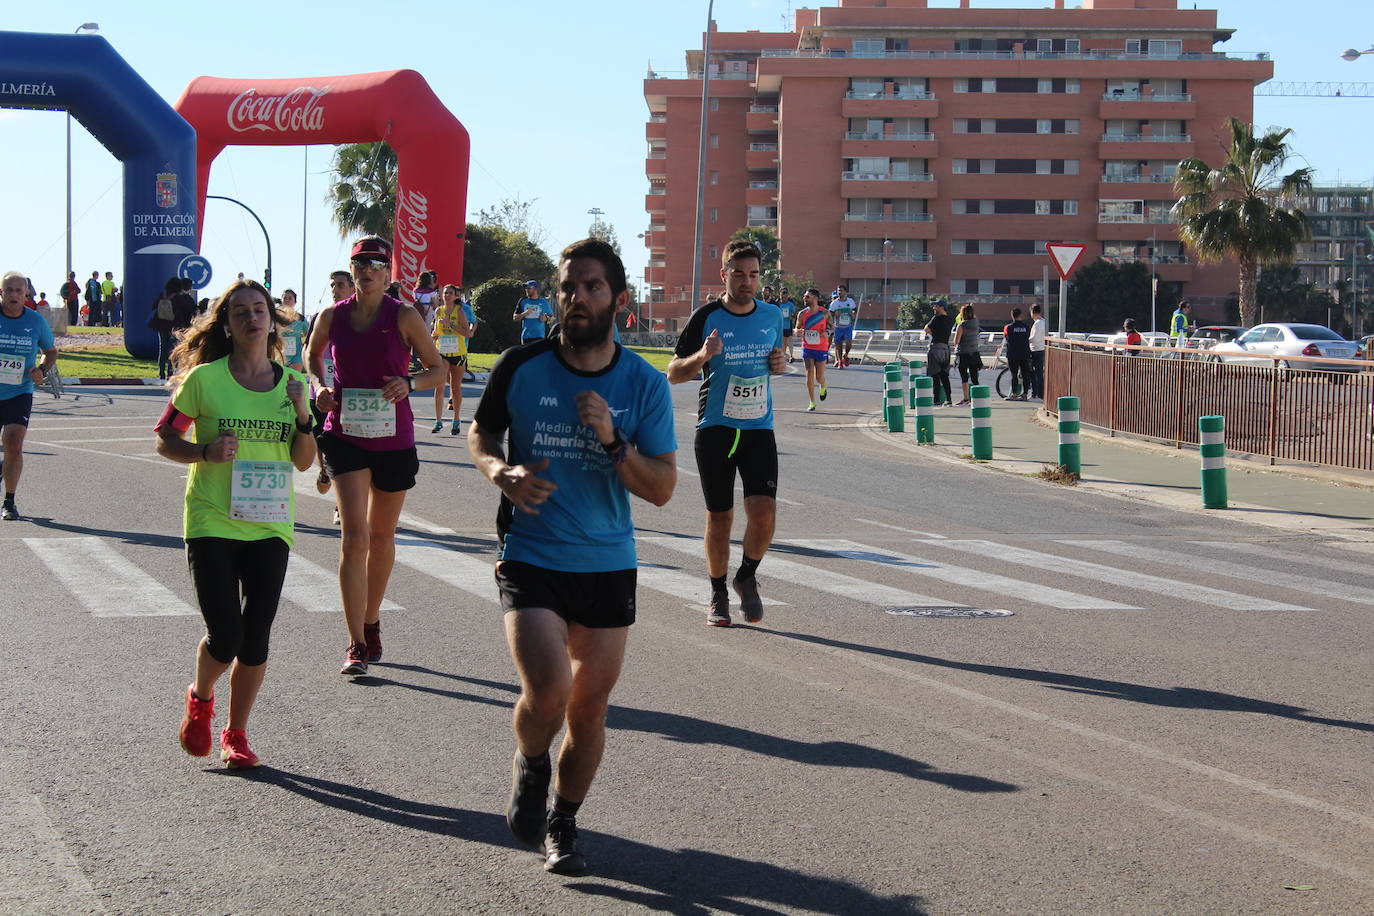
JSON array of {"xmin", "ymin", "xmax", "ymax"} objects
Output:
[{"xmin": 772, "ymin": 630, "xmax": 1374, "ymax": 732}]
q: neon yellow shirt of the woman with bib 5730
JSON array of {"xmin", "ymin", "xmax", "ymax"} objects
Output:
[{"xmin": 172, "ymin": 357, "xmax": 305, "ymax": 545}]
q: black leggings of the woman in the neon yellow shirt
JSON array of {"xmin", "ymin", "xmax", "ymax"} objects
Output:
[{"xmin": 185, "ymin": 537, "xmax": 291, "ymax": 665}]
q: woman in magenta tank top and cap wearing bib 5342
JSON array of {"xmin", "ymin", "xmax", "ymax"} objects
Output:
[{"xmin": 309, "ymin": 236, "xmax": 447, "ymax": 676}]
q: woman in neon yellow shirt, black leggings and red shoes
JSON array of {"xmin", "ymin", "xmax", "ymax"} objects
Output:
[{"xmin": 155, "ymin": 280, "xmax": 315, "ymax": 766}]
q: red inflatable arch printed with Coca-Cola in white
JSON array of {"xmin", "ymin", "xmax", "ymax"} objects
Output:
[{"xmin": 176, "ymin": 70, "xmax": 470, "ymax": 288}]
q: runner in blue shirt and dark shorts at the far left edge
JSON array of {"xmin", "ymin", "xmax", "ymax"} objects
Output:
[{"xmin": 0, "ymin": 271, "xmax": 58, "ymax": 522}]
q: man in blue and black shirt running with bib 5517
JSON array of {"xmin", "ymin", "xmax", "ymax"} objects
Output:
[{"xmin": 668, "ymin": 240, "xmax": 787, "ymax": 626}]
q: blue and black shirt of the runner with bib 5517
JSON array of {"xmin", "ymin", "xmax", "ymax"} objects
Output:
[{"xmin": 673, "ymin": 299, "xmax": 783, "ymax": 430}]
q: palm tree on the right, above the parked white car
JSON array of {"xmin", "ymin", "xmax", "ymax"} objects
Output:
[{"xmin": 1173, "ymin": 118, "xmax": 1312, "ymax": 325}]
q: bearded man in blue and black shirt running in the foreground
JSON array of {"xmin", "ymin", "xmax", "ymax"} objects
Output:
[{"xmin": 467, "ymin": 239, "xmax": 677, "ymax": 875}]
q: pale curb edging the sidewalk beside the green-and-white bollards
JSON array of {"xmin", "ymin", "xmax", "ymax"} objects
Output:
[{"xmin": 853, "ymin": 413, "xmax": 1374, "ymax": 542}]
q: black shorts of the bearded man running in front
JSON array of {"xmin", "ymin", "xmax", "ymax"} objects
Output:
[{"xmin": 496, "ymin": 560, "xmax": 638, "ymax": 629}]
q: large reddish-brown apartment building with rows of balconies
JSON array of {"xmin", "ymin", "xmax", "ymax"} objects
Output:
[{"xmin": 644, "ymin": 0, "xmax": 1272, "ymax": 323}]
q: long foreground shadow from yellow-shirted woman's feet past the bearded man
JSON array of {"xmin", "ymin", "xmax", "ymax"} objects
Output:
[{"xmin": 217, "ymin": 766, "xmax": 925, "ymax": 916}]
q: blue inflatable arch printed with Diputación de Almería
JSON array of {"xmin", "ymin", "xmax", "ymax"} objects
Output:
[{"xmin": 0, "ymin": 32, "xmax": 196, "ymax": 358}]
